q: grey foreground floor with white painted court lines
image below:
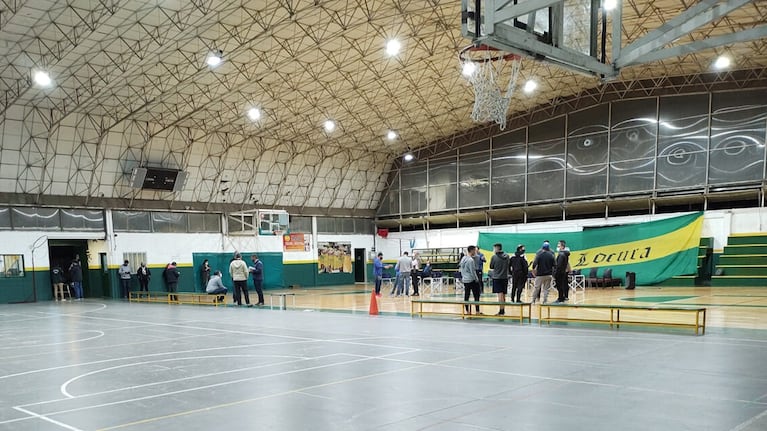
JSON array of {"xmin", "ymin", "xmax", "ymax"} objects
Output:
[{"xmin": 0, "ymin": 300, "xmax": 767, "ymax": 431}]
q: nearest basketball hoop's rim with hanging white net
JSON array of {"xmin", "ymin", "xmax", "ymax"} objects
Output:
[{"xmin": 458, "ymin": 45, "xmax": 522, "ymax": 130}]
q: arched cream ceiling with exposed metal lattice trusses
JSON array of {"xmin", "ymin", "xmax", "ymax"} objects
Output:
[{"xmin": 0, "ymin": 0, "xmax": 767, "ymax": 211}]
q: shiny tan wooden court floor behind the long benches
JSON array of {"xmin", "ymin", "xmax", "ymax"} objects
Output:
[{"xmin": 274, "ymin": 284, "xmax": 767, "ymax": 329}]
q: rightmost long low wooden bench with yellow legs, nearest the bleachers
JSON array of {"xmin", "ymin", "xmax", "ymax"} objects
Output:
[{"xmin": 538, "ymin": 304, "xmax": 706, "ymax": 335}]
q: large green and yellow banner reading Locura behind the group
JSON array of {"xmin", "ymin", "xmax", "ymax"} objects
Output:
[{"xmin": 477, "ymin": 212, "xmax": 703, "ymax": 284}]
